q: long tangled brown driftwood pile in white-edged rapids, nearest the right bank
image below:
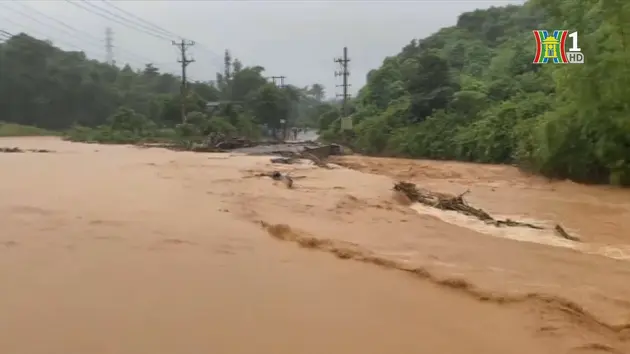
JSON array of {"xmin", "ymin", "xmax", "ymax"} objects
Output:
[{"xmin": 394, "ymin": 182, "xmax": 579, "ymax": 241}]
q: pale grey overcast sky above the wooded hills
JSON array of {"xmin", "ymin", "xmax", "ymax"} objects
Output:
[{"xmin": 0, "ymin": 0, "xmax": 523, "ymax": 96}]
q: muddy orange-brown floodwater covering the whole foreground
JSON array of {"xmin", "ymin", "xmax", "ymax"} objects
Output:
[{"xmin": 0, "ymin": 138, "xmax": 630, "ymax": 354}]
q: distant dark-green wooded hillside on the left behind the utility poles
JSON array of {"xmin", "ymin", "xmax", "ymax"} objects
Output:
[{"xmin": 0, "ymin": 34, "xmax": 332, "ymax": 135}]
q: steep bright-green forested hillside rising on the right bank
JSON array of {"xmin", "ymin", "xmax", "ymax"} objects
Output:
[{"xmin": 320, "ymin": 0, "xmax": 630, "ymax": 185}]
